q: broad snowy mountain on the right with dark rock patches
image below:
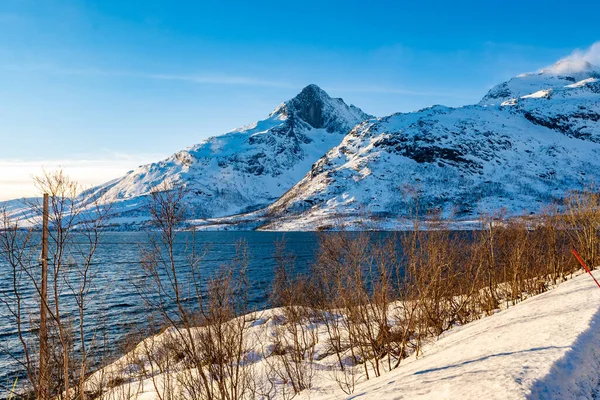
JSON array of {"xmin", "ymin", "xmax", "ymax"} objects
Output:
[{"xmin": 255, "ymin": 61, "xmax": 600, "ymax": 230}]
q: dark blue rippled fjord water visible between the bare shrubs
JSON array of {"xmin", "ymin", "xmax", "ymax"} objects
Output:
[{"xmin": 0, "ymin": 232, "xmax": 318, "ymax": 388}]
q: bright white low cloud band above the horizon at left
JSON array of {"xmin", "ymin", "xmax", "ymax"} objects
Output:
[{"xmin": 0, "ymin": 153, "xmax": 164, "ymax": 201}]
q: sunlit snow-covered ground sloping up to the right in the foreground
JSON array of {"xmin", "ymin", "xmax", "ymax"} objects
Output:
[{"xmin": 95, "ymin": 272, "xmax": 600, "ymax": 400}]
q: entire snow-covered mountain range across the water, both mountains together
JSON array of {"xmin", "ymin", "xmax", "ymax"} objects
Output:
[{"xmin": 4, "ymin": 57, "xmax": 600, "ymax": 230}]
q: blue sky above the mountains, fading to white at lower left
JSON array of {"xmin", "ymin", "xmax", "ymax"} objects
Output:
[{"xmin": 0, "ymin": 0, "xmax": 600, "ymax": 200}]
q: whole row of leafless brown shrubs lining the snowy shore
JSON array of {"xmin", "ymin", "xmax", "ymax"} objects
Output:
[{"xmin": 0, "ymin": 175, "xmax": 600, "ymax": 400}]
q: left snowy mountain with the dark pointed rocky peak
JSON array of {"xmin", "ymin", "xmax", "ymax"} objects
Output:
[{"xmin": 88, "ymin": 85, "xmax": 372, "ymax": 222}]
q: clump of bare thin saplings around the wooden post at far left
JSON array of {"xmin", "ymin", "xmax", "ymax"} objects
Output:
[{"xmin": 0, "ymin": 171, "xmax": 110, "ymax": 400}]
